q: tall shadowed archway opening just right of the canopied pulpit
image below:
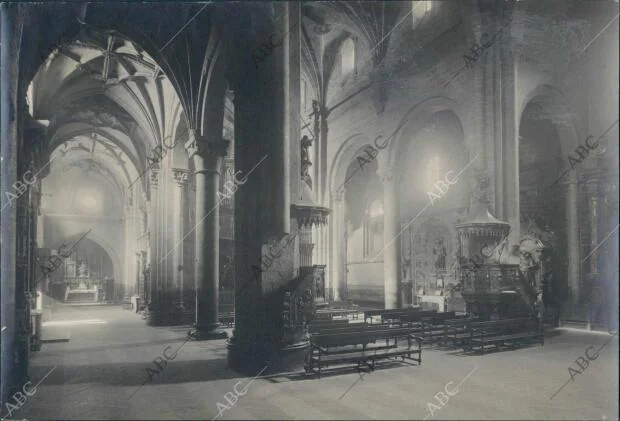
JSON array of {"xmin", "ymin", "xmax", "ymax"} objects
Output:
[{"xmin": 519, "ymin": 96, "xmax": 568, "ymax": 324}]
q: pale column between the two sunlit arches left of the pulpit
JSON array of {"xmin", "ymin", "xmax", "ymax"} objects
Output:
[{"xmin": 380, "ymin": 168, "xmax": 401, "ymax": 309}]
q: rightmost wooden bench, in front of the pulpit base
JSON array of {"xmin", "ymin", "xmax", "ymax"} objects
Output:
[{"xmin": 468, "ymin": 317, "xmax": 544, "ymax": 355}]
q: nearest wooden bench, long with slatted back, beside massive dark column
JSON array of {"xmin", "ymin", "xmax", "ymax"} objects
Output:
[{"xmin": 304, "ymin": 327, "xmax": 422, "ymax": 378}]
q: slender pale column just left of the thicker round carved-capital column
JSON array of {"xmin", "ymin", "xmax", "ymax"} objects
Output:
[{"xmin": 172, "ymin": 168, "xmax": 188, "ymax": 311}]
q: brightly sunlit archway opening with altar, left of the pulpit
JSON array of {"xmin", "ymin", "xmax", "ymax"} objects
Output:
[{"xmin": 399, "ymin": 110, "xmax": 469, "ymax": 311}]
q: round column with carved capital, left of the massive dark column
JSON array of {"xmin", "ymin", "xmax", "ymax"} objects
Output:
[{"xmin": 186, "ymin": 130, "xmax": 228, "ymax": 339}]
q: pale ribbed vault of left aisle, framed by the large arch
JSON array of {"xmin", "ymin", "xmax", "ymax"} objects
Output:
[{"xmin": 29, "ymin": 29, "xmax": 182, "ymax": 199}]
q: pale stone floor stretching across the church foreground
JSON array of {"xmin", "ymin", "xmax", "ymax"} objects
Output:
[{"xmin": 10, "ymin": 307, "xmax": 618, "ymax": 420}]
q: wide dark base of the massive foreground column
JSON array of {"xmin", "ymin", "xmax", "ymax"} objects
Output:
[{"xmin": 226, "ymin": 337, "xmax": 308, "ymax": 376}]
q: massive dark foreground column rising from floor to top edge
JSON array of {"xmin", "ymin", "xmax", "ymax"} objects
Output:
[{"xmin": 228, "ymin": 2, "xmax": 307, "ymax": 375}]
